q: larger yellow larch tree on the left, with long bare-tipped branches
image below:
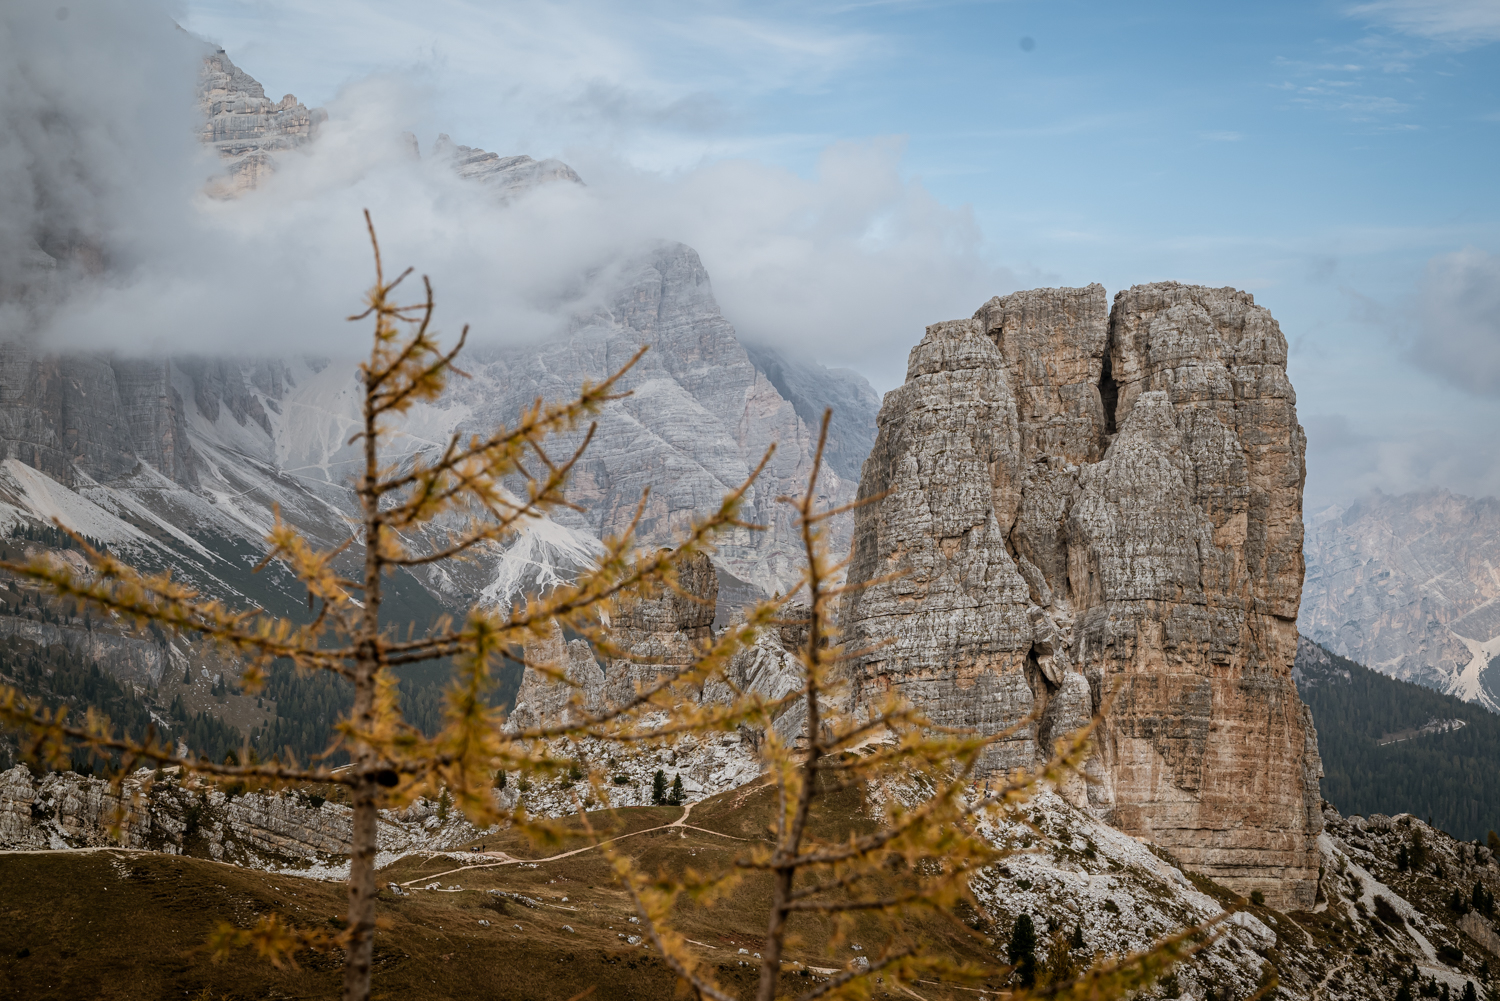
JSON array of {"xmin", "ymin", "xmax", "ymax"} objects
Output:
[{"xmin": 0, "ymin": 213, "xmax": 770, "ymax": 1001}]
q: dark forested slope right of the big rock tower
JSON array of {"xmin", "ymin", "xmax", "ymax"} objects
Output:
[{"xmin": 1298, "ymin": 641, "xmax": 1500, "ymax": 840}]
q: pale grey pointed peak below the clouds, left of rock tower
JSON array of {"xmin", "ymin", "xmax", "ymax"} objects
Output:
[{"xmin": 411, "ymin": 243, "xmax": 854, "ymax": 602}]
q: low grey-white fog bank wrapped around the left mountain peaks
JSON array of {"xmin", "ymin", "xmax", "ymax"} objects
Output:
[{"xmin": 0, "ymin": 3, "xmax": 1016, "ymax": 389}]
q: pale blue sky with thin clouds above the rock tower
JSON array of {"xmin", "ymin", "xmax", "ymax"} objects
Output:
[{"xmin": 179, "ymin": 0, "xmax": 1500, "ymax": 509}]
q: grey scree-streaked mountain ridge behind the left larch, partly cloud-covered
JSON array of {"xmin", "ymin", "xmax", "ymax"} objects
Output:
[{"xmin": 0, "ymin": 50, "xmax": 879, "ymax": 651}]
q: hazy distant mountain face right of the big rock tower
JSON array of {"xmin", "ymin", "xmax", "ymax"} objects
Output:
[{"xmin": 1298, "ymin": 491, "xmax": 1500, "ymax": 711}]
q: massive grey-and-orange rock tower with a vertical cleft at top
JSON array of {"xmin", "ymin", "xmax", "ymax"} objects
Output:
[{"xmin": 845, "ymin": 282, "xmax": 1320, "ymax": 906}]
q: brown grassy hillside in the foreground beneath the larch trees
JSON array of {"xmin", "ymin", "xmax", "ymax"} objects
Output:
[{"xmin": 0, "ymin": 788, "xmax": 993, "ymax": 1001}]
